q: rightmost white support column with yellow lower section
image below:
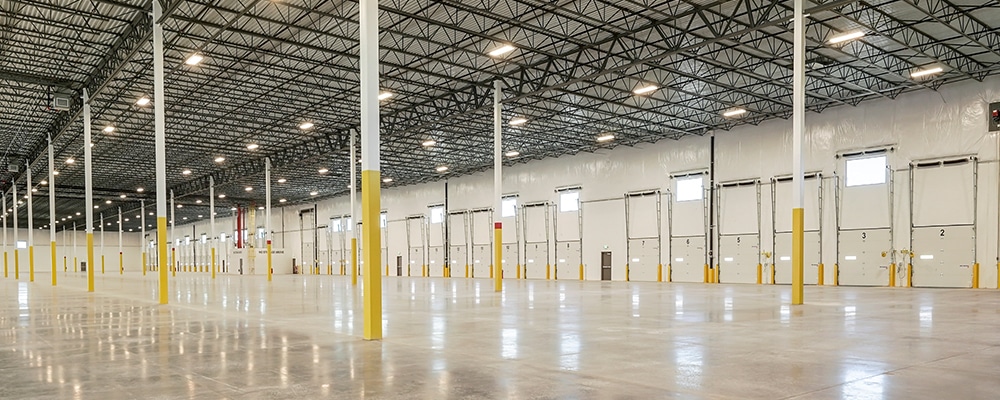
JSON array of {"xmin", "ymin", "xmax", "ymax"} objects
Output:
[{"xmin": 792, "ymin": 0, "xmax": 806, "ymax": 305}]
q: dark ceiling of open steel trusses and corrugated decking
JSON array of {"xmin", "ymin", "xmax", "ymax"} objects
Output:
[{"xmin": 0, "ymin": 0, "xmax": 1000, "ymax": 230}]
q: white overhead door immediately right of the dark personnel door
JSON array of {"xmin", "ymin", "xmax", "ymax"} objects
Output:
[{"xmin": 625, "ymin": 190, "xmax": 663, "ymax": 282}]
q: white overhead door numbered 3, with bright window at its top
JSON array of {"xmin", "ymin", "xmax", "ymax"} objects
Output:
[{"xmin": 837, "ymin": 150, "xmax": 893, "ymax": 286}]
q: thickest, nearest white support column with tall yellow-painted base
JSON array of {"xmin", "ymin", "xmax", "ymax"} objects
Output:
[{"xmin": 360, "ymin": 0, "xmax": 382, "ymax": 340}]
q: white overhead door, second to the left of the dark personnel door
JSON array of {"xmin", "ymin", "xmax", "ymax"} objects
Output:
[{"xmin": 521, "ymin": 202, "xmax": 552, "ymax": 279}]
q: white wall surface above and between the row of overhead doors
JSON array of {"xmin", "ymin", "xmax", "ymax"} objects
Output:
[{"xmin": 143, "ymin": 78, "xmax": 1000, "ymax": 287}]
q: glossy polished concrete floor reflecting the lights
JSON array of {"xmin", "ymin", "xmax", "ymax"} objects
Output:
[{"xmin": 0, "ymin": 271, "xmax": 1000, "ymax": 399}]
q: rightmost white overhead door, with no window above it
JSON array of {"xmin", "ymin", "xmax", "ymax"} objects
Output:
[{"xmin": 910, "ymin": 157, "xmax": 978, "ymax": 288}]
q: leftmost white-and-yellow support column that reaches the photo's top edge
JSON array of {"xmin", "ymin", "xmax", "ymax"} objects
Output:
[{"xmin": 153, "ymin": 1, "xmax": 169, "ymax": 304}]
